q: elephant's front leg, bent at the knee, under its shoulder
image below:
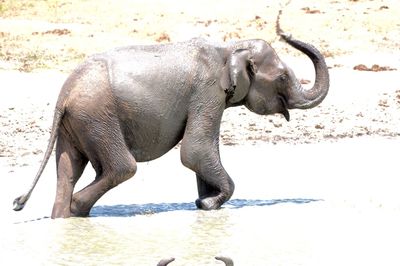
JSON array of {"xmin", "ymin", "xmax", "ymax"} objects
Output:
[{"xmin": 181, "ymin": 95, "xmax": 234, "ymax": 210}]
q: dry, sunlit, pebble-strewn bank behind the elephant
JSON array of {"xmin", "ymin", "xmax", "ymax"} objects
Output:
[{"xmin": 0, "ymin": 0, "xmax": 400, "ymax": 171}]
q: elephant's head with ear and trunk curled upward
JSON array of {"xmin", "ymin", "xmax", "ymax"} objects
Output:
[{"xmin": 225, "ymin": 35, "xmax": 329, "ymax": 121}]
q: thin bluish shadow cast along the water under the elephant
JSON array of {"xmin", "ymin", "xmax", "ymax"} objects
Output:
[{"xmin": 90, "ymin": 198, "xmax": 321, "ymax": 217}]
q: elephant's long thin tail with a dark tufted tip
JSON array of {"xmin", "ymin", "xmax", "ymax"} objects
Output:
[{"xmin": 13, "ymin": 105, "xmax": 65, "ymax": 211}]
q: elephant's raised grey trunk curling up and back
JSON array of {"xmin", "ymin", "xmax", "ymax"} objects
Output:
[{"xmin": 281, "ymin": 34, "xmax": 329, "ymax": 109}]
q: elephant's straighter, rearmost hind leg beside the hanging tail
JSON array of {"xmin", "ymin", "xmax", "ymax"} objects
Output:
[{"xmin": 51, "ymin": 128, "xmax": 88, "ymax": 218}]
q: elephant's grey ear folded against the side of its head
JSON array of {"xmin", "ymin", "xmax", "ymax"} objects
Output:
[{"xmin": 226, "ymin": 49, "xmax": 257, "ymax": 103}]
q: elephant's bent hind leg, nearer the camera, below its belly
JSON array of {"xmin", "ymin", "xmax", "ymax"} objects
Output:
[{"xmin": 67, "ymin": 116, "xmax": 137, "ymax": 217}]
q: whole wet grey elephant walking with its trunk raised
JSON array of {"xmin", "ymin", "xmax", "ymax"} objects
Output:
[{"xmin": 14, "ymin": 36, "xmax": 329, "ymax": 218}]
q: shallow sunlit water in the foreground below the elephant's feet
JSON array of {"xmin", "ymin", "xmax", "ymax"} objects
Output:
[{"xmin": 4, "ymin": 199, "xmax": 400, "ymax": 266}]
